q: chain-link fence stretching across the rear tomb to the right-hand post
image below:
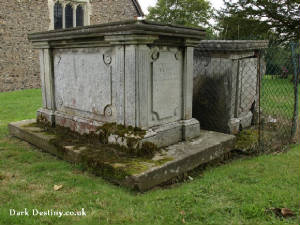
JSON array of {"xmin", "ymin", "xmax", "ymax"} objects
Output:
[{"xmin": 193, "ymin": 40, "xmax": 299, "ymax": 151}]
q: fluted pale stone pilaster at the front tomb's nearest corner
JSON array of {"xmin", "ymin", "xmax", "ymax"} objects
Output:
[{"xmin": 105, "ymin": 35, "xmax": 158, "ymax": 129}]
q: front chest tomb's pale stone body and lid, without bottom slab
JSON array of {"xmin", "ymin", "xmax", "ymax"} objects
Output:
[{"xmin": 29, "ymin": 20, "xmax": 205, "ymax": 147}]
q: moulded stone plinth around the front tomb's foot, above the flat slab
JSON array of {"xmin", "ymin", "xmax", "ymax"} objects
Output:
[{"xmin": 37, "ymin": 109, "xmax": 200, "ymax": 148}]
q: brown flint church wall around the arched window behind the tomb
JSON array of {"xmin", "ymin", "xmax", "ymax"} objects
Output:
[{"xmin": 0, "ymin": 0, "xmax": 138, "ymax": 92}]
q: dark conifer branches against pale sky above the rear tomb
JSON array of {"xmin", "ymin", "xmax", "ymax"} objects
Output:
[{"xmin": 218, "ymin": 0, "xmax": 300, "ymax": 42}]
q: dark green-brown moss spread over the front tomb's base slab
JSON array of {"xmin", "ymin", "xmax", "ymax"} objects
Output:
[{"xmin": 22, "ymin": 123, "xmax": 172, "ymax": 181}]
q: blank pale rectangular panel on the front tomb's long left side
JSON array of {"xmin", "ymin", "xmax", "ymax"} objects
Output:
[{"xmin": 54, "ymin": 48, "xmax": 112, "ymax": 116}]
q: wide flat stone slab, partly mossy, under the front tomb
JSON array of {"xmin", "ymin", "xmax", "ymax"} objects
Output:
[{"xmin": 9, "ymin": 120, "xmax": 235, "ymax": 191}]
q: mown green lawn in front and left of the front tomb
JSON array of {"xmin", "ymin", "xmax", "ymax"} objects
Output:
[{"xmin": 0, "ymin": 90, "xmax": 300, "ymax": 225}]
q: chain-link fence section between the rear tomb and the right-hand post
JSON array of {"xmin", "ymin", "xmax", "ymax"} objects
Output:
[{"xmin": 260, "ymin": 44, "xmax": 299, "ymax": 148}]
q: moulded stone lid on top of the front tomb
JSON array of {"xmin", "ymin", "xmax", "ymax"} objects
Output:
[{"xmin": 28, "ymin": 19, "xmax": 205, "ymax": 42}]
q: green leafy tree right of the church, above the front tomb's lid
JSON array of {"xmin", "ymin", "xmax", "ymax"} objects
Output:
[{"xmin": 147, "ymin": 0, "xmax": 212, "ymax": 26}]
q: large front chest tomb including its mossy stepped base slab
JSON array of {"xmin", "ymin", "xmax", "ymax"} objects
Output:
[{"xmin": 9, "ymin": 20, "xmax": 235, "ymax": 191}]
